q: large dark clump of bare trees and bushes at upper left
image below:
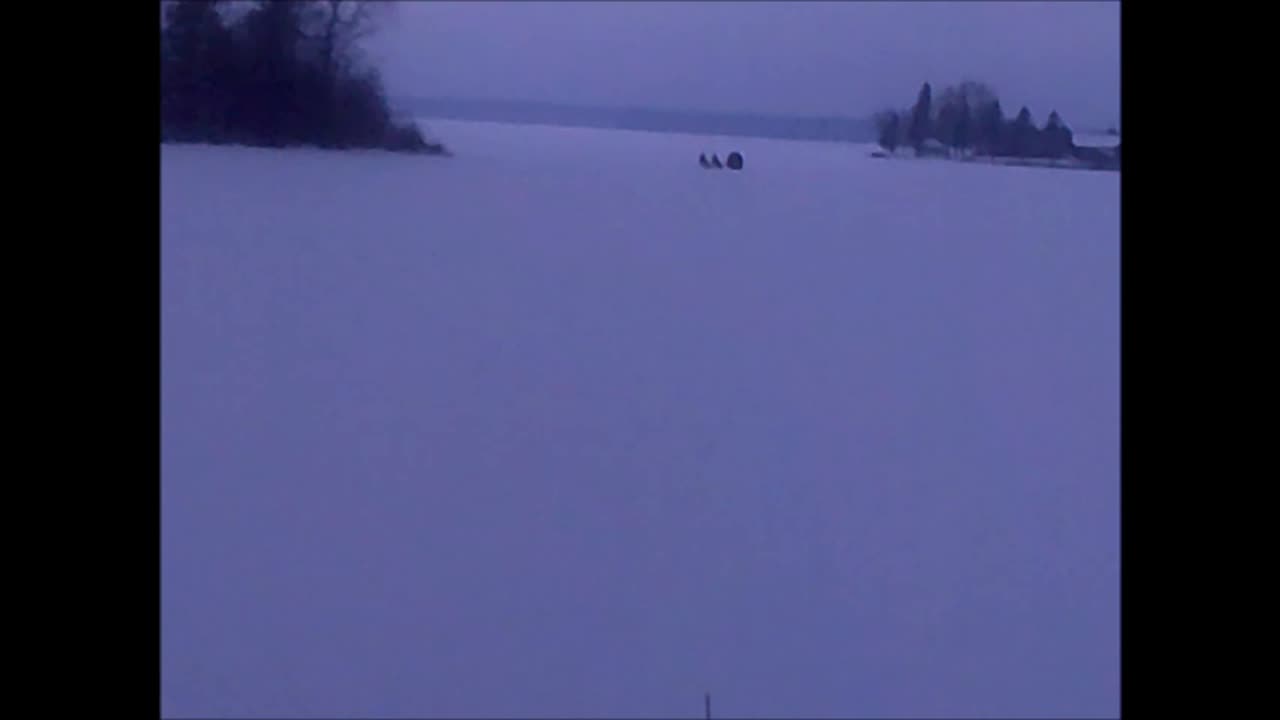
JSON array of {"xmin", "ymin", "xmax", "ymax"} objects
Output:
[{"xmin": 160, "ymin": 0, "xmax": 444, "ymax": 152}]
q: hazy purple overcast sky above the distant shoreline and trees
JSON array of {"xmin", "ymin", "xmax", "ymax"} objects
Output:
[{"xmin": 367, "ymin": 1, "xmax": 1120, "ymax": 126}]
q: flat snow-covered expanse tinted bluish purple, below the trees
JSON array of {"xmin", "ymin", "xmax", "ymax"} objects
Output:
[{"xmin": 161, "ymin": 122, "xmax": 1120, "ymax": 717}]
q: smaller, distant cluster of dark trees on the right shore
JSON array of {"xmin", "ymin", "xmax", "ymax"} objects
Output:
[{"xmin": 876, "ymin": 82, "xmax": 1075, "ymax": 158}]
